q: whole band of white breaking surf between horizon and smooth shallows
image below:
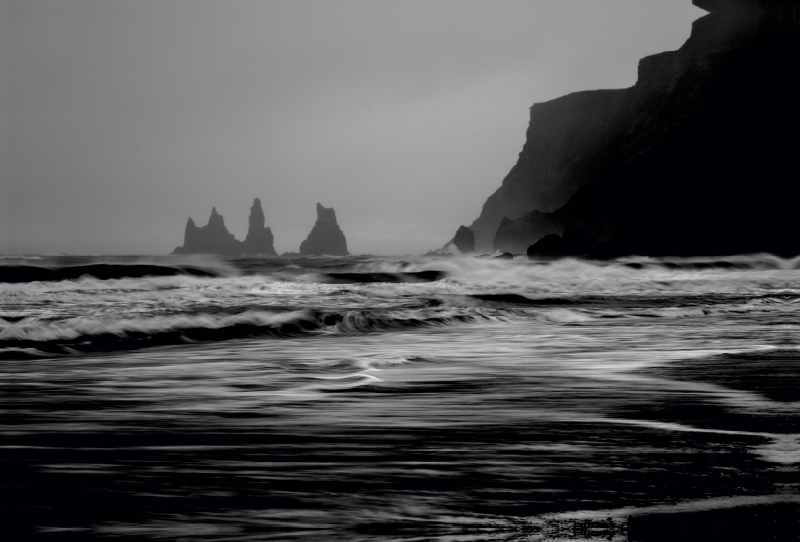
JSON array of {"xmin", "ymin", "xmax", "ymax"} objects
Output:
[{"xmin": 6, "ymin": 255, "xmax": 800, "ymax": 359}]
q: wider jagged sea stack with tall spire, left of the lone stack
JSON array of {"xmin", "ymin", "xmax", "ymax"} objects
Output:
[{"xmin": 172, "ymin": 198, "xmax": 275, "ymax": 256}]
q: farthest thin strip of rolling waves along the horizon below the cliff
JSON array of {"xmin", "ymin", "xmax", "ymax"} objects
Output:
[{"xmin": 6, "ymin": 254, "xmax": 800, "ymax": 284}]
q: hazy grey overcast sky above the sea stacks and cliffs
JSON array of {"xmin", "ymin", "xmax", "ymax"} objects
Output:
[{"xmin": 0, "ymin": 0, "xmax": 704, "ymax": 255}]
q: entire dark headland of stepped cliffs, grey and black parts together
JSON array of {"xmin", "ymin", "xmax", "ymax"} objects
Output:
[{"xmin": 460, "ymin": 0, "xmax": 800, "ymax": 256}]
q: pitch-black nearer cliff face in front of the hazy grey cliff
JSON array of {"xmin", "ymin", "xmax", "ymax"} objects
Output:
[{"xmin": 553, "ymin": 0, "xmax": 800, "ymax": 255}]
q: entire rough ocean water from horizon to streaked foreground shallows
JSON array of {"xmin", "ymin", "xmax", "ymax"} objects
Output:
[{"xmin": 0, "ymin": 255, "xmax": 800, "ymax": 542}]
